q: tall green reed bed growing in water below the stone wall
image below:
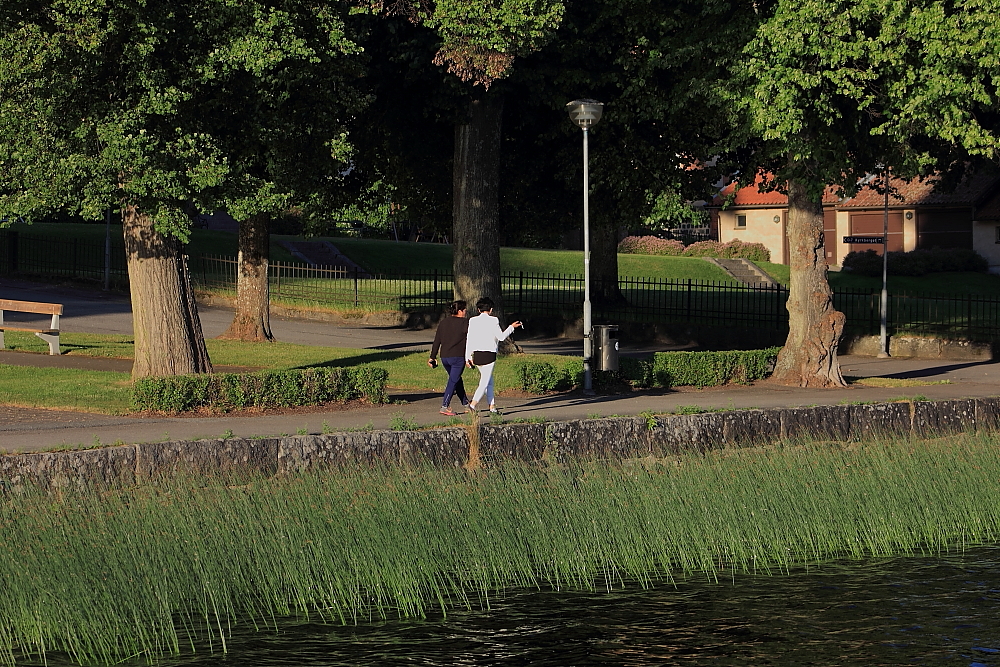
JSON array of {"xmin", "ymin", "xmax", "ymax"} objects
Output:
[{"xmin": 0, "ymin": 435, "xmax": 1000, "ymax": 664}]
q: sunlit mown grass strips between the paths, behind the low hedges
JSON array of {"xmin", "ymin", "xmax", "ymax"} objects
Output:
[{"xmin": 0, "ymin": 331, "xmax": 569, "ymax": 414}]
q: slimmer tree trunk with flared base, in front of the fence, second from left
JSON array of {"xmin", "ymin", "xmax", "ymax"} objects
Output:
[{"xmin": 219, "ymin": 213, "xmax": 274, "ymax": 343}]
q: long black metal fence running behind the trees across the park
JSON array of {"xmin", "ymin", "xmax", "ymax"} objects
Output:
[{"xmin": 0, "ymin": 230, "xmax": 1000, "ymax": 339}]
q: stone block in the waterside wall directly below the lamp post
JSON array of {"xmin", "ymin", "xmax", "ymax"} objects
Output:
[{"xmin": 546, "ymin": 417, "xmax": 650, "ymax": 459}]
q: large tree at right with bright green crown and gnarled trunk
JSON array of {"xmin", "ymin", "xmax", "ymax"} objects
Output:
[{"xmin": 728, "ymin": 0, "xmax": 998, "ymax": 387}]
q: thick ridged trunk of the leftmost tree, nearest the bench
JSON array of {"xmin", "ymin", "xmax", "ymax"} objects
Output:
[{"xmin": 122, "ymin": 206, "xmax": 212, "ymax": 378}]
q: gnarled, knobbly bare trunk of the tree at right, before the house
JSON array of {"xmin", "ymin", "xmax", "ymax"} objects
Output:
[{"xmin": 773, "ymin": 180, "xmax": 846, "ymax": 387}]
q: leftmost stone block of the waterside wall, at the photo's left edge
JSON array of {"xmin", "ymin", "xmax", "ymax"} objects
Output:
[{"xmin": 0, "ymin": 445, "xmax": 136, "ymax": 489}]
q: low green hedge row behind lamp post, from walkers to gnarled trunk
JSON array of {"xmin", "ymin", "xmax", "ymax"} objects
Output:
[{"xmin": 517, "ymin": 347, "xmax": 781, "ymax": 394}]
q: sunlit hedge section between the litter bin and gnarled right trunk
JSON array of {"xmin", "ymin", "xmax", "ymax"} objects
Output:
[{"xmin": 653, "ymin": 347, "xmax": 781, "ymax": 387}]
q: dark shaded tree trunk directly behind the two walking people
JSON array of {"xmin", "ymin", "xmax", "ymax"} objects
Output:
[{"xmin": 452, "ymin": 93, "xmax": 514, "ymax": 353}]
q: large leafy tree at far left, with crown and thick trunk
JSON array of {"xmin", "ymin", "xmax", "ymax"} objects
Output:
[{"xmin": 0, "ymin": 0, "xmax": 364, "ymax": 370}]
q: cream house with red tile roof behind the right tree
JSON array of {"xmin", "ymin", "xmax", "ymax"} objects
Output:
[{"xmin": 707, "ymin": 173, "xmax": 1000, "ymax": 273}]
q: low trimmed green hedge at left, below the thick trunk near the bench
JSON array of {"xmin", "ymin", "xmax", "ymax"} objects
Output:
[{"xmin": 132, "ymin": 366, "xmax": 389, "ymax": 412}]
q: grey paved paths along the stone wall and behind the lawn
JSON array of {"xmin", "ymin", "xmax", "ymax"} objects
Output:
[{"xmin": 0, "ymin": 280, "xmax": 1000, "ymax": 451}]
